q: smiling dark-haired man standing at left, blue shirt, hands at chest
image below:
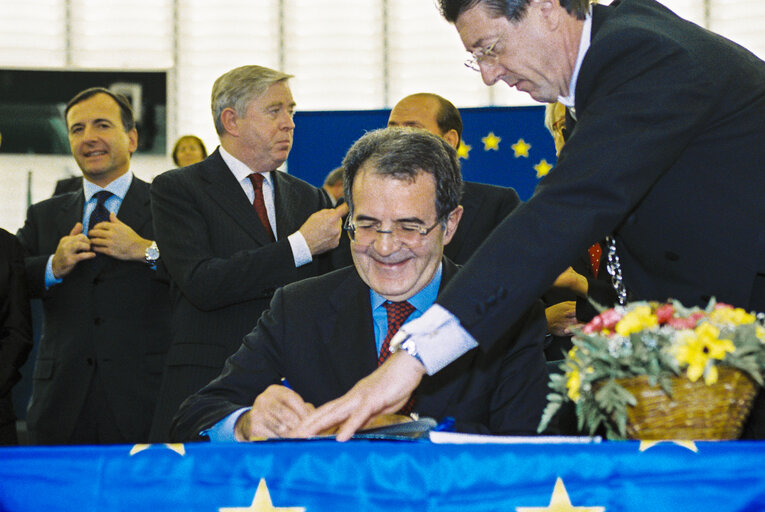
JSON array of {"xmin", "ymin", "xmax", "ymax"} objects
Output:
[{"xmin": 18, "ymin": 88, "xmax": 170, "ymax": 444}]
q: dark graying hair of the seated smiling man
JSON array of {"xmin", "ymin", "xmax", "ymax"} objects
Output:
[{"xmin": 343, "ymin": 127, "xmax": 462, "ymax": 220}]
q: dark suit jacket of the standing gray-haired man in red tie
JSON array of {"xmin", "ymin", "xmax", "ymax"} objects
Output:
[{"xmin": 152, "ymin": 151, "xmax": 330, "ymax": 442}]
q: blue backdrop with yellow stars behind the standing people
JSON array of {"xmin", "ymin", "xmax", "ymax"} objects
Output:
[{"xmin": 288, "ymin": 106, "xmax": 555, "ymax": 200}]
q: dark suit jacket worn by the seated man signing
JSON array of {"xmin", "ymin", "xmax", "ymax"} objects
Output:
[{"xmin": 173, "ymin": 259, "xmax": 547, "ymax": 440}]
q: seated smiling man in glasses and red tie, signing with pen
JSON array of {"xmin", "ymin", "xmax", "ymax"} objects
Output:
[{"xmin": 174, "ymin": 129, "xmax": 547, "ymax": 441}]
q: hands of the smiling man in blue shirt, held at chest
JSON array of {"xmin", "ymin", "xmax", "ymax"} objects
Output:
[{"xmin": 51, "ymin": 213, "xmax": 151, "ymax": 279}]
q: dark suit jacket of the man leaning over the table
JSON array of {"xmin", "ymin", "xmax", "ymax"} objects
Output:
[{"xmin": 439, "ymin": 0, "xmax": 765, "ymax": 436}]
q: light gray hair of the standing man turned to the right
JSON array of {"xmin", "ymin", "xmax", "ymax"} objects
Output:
[{"xmin": 210, "ymin": 66, "xmax": 294, "ymax": 135}]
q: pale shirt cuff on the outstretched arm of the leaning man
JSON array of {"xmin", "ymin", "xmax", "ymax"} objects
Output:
[{"xmin": 396, "ymin": 304, "xmax": 478, "ymax": 375}]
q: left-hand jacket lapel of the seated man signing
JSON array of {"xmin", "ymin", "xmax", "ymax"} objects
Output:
[{"xmin": 325, "ymin": 270, "xmax": 377, "ymax": 389}]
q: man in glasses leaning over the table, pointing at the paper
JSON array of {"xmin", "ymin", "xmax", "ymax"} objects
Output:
[{"xmin": 297, "ymin": 0, "xmax": 765, "ymax": 439}]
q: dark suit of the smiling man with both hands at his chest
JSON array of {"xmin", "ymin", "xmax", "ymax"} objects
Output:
[{"xmin": 18, "ymin": 177, "xmax": 170, "ymax": 444}]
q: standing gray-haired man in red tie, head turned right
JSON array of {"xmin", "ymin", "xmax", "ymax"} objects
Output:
[{"xmin": 152, "ymin": 66, "xmax": 347, "ymax": 441}]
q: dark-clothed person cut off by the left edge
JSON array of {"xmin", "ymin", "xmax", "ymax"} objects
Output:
[{"xmin": 0, "ymin": 229, "xmax": 32, "ymax": 445}]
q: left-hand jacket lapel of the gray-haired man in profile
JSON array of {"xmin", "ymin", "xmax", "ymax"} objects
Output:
[{"xmin": 201, "ymin": 150, "xmax": 279, "ymax": 245}]
